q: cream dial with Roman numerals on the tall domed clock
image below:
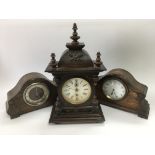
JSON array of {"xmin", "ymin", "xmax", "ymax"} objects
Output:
[{"xmin": 62, "ymin": 78, "xmax": 92, "ymax": 104}]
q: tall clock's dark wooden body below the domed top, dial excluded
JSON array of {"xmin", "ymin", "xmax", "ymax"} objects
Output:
[{"xmin": 49, "ymin": 73, "xmax": 105, "ymax": 124}]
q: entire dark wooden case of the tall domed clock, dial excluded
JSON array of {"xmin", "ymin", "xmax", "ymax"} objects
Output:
[{"xmin": 46, "ymin": 24, "xmax": 106, "ymax": 124}]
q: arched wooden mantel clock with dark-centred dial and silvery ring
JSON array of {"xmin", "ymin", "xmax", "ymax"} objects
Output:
[{"xmin": 6, "ymin": 72, "xmax": 57, "ymax": 119}]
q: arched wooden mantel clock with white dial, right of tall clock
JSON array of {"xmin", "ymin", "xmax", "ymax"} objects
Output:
[{"xmin": 96, "ymin": 68, "xmax": 150, "ymax": 119}]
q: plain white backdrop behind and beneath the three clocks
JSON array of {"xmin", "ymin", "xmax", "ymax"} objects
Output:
[{"xmin": 0, "ymin": 20, "xmax": 155, "ymax": 135}]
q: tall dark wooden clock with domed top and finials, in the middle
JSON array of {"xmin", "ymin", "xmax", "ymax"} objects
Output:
[{"xmin": 46, "ymin": 23, "xmax": 106, "ymax": 123}]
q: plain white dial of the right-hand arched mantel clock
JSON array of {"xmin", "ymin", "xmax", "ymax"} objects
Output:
[{"xmin": 102, "ymin": 79, "xmax": 127, "ymax": 100}]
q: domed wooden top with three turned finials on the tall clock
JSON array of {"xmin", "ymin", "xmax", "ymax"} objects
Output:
[{"xmin": 46, "ymin": 23, "xmax": 106, "ymax": 74}]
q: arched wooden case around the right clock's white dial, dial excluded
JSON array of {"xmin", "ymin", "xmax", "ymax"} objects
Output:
[{"xmin": 96, "ymin": 69, "xmax": 150, "ymax": 119}]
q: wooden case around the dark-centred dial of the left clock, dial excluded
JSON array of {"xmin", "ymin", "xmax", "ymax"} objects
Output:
[{"xmin": 6, "ymin": 73, "xmax": 57, "ymax": 119}]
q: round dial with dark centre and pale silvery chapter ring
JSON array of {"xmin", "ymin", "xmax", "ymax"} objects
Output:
[{"xmin": 23, "ymin": 83, "xmax": 50, "ymax": 106}]
